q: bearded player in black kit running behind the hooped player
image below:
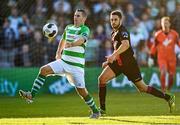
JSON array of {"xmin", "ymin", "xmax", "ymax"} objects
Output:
[{"xmin": 98, "ymin": 10, "xmax": 175, "ymax": 115}]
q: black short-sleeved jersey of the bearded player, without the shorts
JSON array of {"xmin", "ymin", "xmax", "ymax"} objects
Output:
[{"xmin": 111, "ymin": 25, "xmax": 134, "ymax": 62}]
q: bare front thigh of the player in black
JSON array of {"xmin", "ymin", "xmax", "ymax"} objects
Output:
[{"xmin": 98, "ymin": 66, "xmax": 116, "ymax": 83}]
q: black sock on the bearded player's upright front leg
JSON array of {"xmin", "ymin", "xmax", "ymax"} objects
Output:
[{"xmin": 99, "ymin": 85, "xmax": 106, "ymax": 110}]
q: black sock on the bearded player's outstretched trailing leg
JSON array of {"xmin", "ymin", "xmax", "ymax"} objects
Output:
[{"xmin": 147, "ymin": 86, "xmax": 170, "ymax": 101}]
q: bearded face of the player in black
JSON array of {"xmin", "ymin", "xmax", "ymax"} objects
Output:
[{"xmin": 110, "ymin": 15, "xmax": 122, "ymax": 29}]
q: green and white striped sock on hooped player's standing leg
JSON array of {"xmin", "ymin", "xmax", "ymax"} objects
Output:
[{"xmin": 84, "ymin": 94, "xmax": 99, "ymax": 113}]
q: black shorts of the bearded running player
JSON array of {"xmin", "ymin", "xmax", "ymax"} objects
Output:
[{"xmin": 108, "ymin": 56, "xmax": 142, "ymax": 83}]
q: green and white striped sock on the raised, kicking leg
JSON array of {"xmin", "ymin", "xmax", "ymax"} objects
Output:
[{"xmin": 31, "ymin": 74, "xmax": 46, "ymax": 98}]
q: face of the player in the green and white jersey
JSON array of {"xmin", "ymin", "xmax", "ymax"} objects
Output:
[{"xmin": 74, "ymin": 11, "xmax": 85, "ymax": 26}]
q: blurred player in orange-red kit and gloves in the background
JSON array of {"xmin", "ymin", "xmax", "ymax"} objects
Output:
[{"xmin": 148, "ymin": 16, "xmax": 180, "ymax": 92}]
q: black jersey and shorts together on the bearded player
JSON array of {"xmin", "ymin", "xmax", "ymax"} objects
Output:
[{"xmin": 108, "ymin": 26, "xmax": 142, "ymax": 83}]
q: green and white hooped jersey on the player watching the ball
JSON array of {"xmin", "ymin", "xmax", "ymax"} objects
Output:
[{"xmin": 62, "ymin": 25, "xmax": 90, "ymax": 68}]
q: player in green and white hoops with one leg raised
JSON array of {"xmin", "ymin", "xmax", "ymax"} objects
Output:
[{"xmin": 19, "ymin": 9, "xmax": 100, "ymax": 118}]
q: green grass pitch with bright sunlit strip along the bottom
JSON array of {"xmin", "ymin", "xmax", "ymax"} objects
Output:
[{"xmin": 0, "ymin": 91, "xmax": 180, "ymax": 124}]
